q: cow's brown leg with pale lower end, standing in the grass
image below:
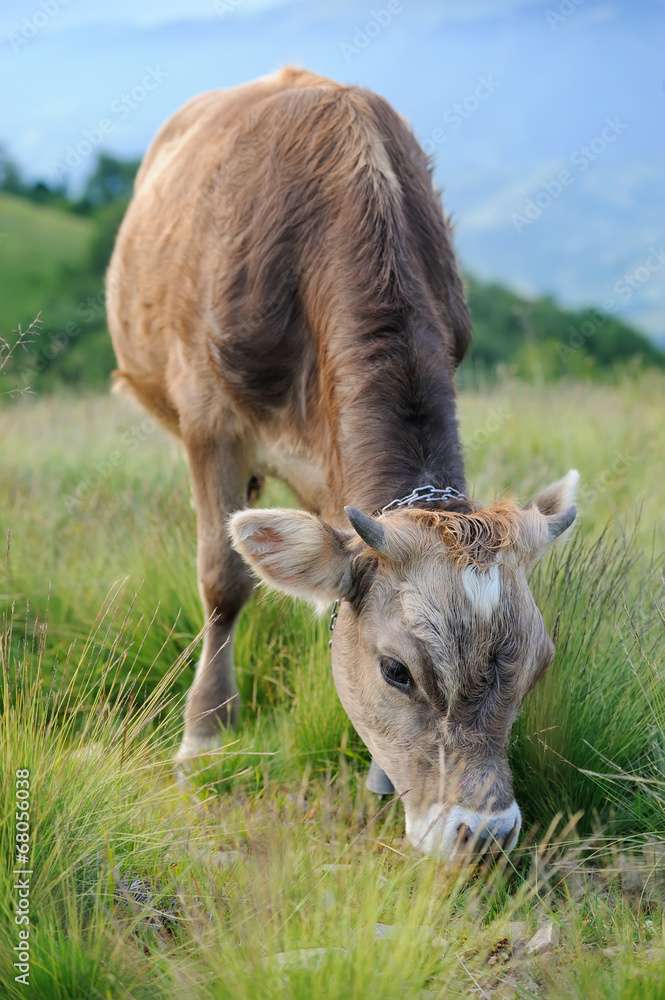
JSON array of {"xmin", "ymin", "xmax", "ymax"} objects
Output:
[{"xmin": 178, "ymin": 432, "xmax": 258, "ymax": 762}]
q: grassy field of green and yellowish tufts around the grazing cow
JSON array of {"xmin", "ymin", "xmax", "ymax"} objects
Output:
[{"xmin": 0, "ymin": 373, "xmax": 665, "ymax": 1000}]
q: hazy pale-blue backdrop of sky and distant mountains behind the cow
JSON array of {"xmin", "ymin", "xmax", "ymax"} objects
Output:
[{"xmin": 0, "ymin": 0, "xmax": 665, "ymax": 343}]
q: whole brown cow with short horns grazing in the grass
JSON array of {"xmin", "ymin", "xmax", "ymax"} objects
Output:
[{"xmin": 107, "ymin": 68, "xmax": 577, "ymax": 859}]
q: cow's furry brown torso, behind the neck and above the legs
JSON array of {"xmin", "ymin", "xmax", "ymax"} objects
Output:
[{"xmin": 107, "ymin": 69, "xmax": 466, "ymax": 428}]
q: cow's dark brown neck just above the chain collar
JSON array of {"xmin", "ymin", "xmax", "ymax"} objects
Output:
[{"xmin": 328, "ymin": 319, "xmax": 465, "ymax": 512}]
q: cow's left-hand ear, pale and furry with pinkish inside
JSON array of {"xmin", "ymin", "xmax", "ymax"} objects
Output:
[{"xmin": 229, "ymin": 508, "xmax": 351, "ymax": 609}]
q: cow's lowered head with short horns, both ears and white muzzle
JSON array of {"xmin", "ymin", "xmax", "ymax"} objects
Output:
[{"xmin": 230, "ymin": 471, "xmax": 578, "ymax": 858}]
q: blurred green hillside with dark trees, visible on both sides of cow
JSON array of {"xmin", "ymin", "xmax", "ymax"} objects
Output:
[{"xmin": 0, "ymin": 182, "xmax": 665, "ymax": 391}]
